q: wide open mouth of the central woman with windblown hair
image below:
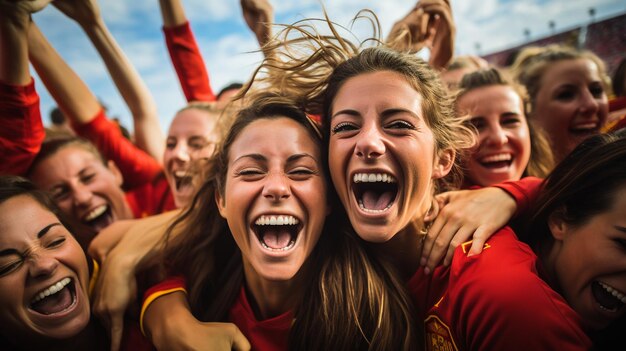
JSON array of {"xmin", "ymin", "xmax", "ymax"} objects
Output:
[{"xmin": 352, "ymin": 173, "xmax": 398, "ymax": 213}]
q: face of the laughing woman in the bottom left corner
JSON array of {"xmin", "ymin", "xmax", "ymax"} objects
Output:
[{"xmin": 0, "ymin": 195, "xmax": 90, "ymax": 348}]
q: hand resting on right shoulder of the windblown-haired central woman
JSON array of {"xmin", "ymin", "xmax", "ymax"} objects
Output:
[{"xmin": 421, "ymin": 187, "xmax": 517, "ymax": 271}]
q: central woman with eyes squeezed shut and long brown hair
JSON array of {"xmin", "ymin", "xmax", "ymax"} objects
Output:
[{"xmin": 151, "ymin": 94, "xmax": 417, "ymax": 350}]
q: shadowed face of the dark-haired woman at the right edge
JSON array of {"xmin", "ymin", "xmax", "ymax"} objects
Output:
[{"xmin": 543, "ymin": 186, "xmax": 626, "ymax": 330}]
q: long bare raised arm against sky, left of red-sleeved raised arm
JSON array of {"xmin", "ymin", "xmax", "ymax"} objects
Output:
[{"xmin": 53, "ymin": 0, "xmax": 165, "ymax": 160}]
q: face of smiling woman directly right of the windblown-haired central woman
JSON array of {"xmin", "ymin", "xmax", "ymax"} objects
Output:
[{"xmin": 457, "ymin": 85, "xmax": 530, "ymax": 186}]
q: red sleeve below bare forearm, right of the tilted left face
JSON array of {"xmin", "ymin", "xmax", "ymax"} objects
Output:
[{"xmin": 72, "ymin": 111, "xmax": 162, "ymax": 190}]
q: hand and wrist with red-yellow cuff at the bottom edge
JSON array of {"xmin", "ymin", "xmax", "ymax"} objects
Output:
[{"xmin": 143, "ymin": 292, "xmax": 250, "ymax": 351}]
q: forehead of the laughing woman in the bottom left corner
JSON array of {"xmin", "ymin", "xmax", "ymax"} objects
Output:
[{"xmin": 0, "ymin": 195, "xmax": 59, "ymax": 247}]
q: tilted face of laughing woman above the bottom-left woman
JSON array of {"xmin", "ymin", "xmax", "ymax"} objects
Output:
[{"xmin": 31, "ymin": 145, "xmax": 133, "ymax": 231}]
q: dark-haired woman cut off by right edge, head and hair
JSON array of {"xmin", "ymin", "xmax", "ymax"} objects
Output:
[{"xmin": 526, "ymin": 130, "xmax": 626, "ymax": 349}]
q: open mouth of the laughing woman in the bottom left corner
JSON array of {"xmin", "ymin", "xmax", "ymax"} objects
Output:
[{"xmin": 29, "ymin": 278, "xmax": 76, "ymax": 316}]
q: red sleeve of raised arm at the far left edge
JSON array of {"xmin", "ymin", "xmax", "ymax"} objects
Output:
[{"xmin": 0, "ymin": 80, "xmax": 46, "ymax": 175}]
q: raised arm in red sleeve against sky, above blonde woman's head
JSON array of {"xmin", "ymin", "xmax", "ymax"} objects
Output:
[{"xmin": 159, "ymin": 0, "xmax": 215, "ymax": 102}]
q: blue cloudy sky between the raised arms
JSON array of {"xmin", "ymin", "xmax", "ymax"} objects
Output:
[{"xmin": 33, "ymin": 0, "xmax": 626, "ymax": 132}]
